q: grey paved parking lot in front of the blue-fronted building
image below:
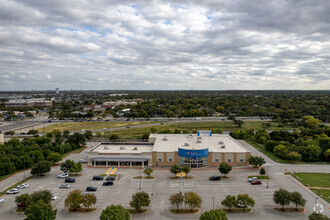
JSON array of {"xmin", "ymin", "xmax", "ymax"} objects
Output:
[{"xmin": 0, "ymin": 141, "xmax": 328, "ymax": 220}]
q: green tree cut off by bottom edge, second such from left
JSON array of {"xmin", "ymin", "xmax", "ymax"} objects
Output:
[{"xmin": 100, "ymin": 205, "xmax": 130, "ymax": 220}]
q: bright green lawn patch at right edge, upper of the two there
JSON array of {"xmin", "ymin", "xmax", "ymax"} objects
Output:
[{"xmin": 292, "ymin": 172, "xmax": 330, "ymax": 188}]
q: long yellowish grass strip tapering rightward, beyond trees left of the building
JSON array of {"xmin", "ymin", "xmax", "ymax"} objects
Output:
[{"xmin": 38, "ymin": 121, "xmax": 159, "ymax": 132}]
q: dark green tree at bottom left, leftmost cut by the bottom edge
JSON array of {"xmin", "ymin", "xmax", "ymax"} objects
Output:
[{"xmin": 24, "ymin": 200, "xmax": 57, "ymax": 220}]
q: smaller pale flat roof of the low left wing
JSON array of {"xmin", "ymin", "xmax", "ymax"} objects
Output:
[{"xmin": 89, "ymin": 142, "xmax": 153, "ymax": 155}]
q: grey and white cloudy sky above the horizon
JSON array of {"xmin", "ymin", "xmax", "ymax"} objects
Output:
[{"xmin": 0, "ymin": 0, "xmax": 330, "ymax": 90}]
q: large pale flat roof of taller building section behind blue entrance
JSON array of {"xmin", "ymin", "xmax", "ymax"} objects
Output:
[{"xmin": 149, "ymin": 134, "xmax": 250, "ymax": 153}]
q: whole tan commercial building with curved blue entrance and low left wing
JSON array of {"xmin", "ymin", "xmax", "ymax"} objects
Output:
[{"xmin": 88, "ymin": 131, "xmax": 251, "ymax": 168}]
